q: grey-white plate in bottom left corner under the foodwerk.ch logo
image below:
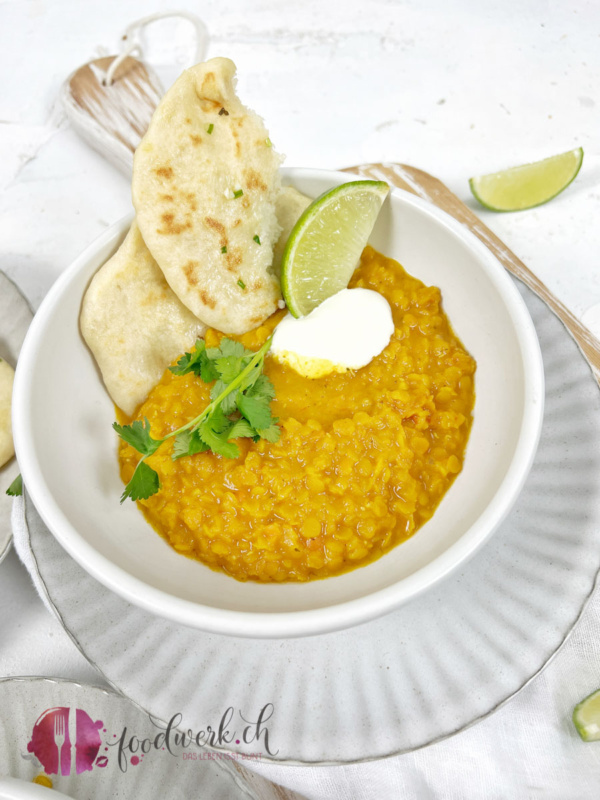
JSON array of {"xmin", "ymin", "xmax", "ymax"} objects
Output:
[{"xmin": 0, "ymin": 677, "xmax": 296, "ymax": 800}]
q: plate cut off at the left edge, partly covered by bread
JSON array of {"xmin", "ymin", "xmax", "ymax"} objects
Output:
[{"xmin": 0, "ymin": 272, "xmax": 33, "ymax": 561}]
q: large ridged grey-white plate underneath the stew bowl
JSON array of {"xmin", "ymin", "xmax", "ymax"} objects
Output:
[{"xmin": 17, "ymin": 285, "xmax": 600, "ymax": 763}]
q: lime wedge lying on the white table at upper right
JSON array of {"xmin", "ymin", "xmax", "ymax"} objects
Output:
[{"xmin": 469, "ymin": 147, "xmax": 583, "ymax": 211}]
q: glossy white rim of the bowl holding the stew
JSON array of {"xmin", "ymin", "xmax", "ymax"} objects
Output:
[{"xmin": 12, "ymin": 168, "xmax": 544, "ymax": 639}]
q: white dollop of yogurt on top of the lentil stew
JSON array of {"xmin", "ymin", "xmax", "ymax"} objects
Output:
[{"xmin": 271, "ymin": 289, "xmax": 394, "ymax": 378}]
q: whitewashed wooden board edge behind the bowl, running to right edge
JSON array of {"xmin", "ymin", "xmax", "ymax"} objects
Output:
[{"xmin": 344, "ymin": 164, "xmax": 600, "ymax": 382}]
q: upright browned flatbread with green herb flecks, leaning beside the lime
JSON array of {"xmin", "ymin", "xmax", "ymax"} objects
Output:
[{"xmin": 132, "ymin": 58, "xmax": 282, "ymax": 334}]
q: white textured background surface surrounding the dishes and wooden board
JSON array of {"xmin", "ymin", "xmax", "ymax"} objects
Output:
[{"xmin": 0, "ymin": 0, "xmax": 600, "ymax": 800}]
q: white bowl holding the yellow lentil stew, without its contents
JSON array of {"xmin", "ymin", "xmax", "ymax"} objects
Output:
[{"xmin": 13, "ymin": 169, "xmax": 544, "ymax": 637}]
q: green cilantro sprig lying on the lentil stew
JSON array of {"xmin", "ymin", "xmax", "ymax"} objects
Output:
[{"xmin": 113, "ymin": 337, "xmax": 280, "ymax": 503}]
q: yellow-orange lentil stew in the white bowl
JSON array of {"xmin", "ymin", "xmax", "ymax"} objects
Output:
[{"xmin": 119, "ymin": 247, "xmax": 476, "ymax": 582}]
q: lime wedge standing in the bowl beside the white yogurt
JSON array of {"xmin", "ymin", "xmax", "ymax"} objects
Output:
[{"xmin": 281, "ymin": 181, "xmax": 390, "ymax": 317}]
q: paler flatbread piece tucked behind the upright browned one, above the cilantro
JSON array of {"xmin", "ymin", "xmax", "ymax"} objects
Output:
[{"xmin": 80, "ymin": 221, "xmax": 206, "ymax": 416}]
